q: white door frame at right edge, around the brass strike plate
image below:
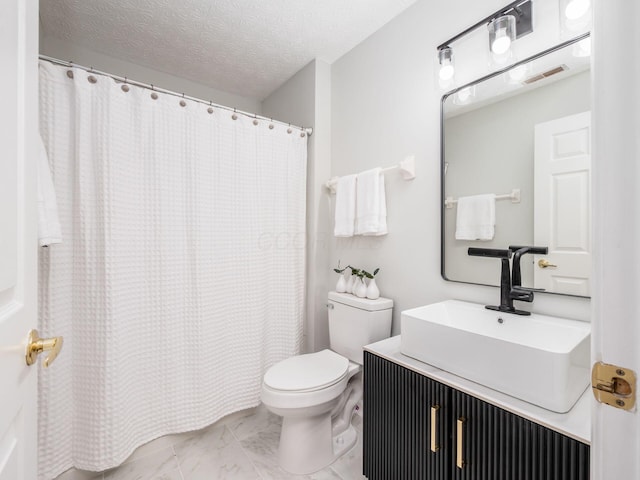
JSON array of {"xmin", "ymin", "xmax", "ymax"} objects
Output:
[{"xmin": 591, "ymin": 0, "xmax": 640, "ymax": 480}]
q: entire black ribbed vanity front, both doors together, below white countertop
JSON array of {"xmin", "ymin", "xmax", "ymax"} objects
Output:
[{"xmin": 363, "ymin": 352, "xmax": 589, "ymax": 480}]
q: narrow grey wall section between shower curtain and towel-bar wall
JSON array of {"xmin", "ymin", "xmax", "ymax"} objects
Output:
[{"xmin": 262, "ymin": 60, "xmax": 331, "ymax": 352}]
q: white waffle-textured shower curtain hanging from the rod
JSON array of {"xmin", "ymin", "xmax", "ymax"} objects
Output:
[{"xmin": 39, "ymin": 62, "xmax": 307, "ymax": 479}]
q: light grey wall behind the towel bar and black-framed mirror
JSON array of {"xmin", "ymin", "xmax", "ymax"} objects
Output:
[{"xmin": 325, "ymin": 0, "xmax": 590, "ymax": 334}]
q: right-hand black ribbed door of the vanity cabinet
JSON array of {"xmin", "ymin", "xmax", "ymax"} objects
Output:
[{"xmin": 449, "ymin": 390, "xmax": 589, "ymax": 480}]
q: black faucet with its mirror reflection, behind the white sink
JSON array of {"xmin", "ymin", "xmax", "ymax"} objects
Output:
[{"xmin": 467, "ymin": 246, "xmax": 548, "ymax": 315}]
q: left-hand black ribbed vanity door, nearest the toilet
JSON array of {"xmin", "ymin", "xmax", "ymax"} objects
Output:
[{"xmin": 363, "ymin": 352, "xmax": 452, "ymax": 480}]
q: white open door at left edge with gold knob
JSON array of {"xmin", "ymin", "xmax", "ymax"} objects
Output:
[{"xmin": 0, "ymin": 0, "xmax": 38, "ymax": 480}]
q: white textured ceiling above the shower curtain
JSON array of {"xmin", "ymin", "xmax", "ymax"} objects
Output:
[{"xmin": 40, "ymin": 0, "xmax": 416, "ymax": 100}]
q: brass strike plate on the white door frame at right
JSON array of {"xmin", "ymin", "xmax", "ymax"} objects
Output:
[{"xmin": 591, "ymin": 362, "xmax": 636, "ymax": 410}]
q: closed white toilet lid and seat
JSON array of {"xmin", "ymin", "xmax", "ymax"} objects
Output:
[{"xmin": 264, "ymin": 350, "xmax": 349, "ymax": 393}]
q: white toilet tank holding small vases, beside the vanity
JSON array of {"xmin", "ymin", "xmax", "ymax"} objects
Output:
[{"xmin": 328, "ymin": 292, "xmax": 393, "ymax": 365}]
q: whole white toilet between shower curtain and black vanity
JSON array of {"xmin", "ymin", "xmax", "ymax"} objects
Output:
[{"xmin": 261, "ymin": 292, "xmax": 393, "ymax": 475}]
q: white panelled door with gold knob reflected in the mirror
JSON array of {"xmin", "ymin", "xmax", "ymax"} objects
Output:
[{"xmin": 533, "ymin": 112, "xmax": 592, "ymax": 297}]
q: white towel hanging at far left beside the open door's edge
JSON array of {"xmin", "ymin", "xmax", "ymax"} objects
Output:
[{"xmin": 36, "ymin": 136, "xmax": 62, "ymax": 247}]
